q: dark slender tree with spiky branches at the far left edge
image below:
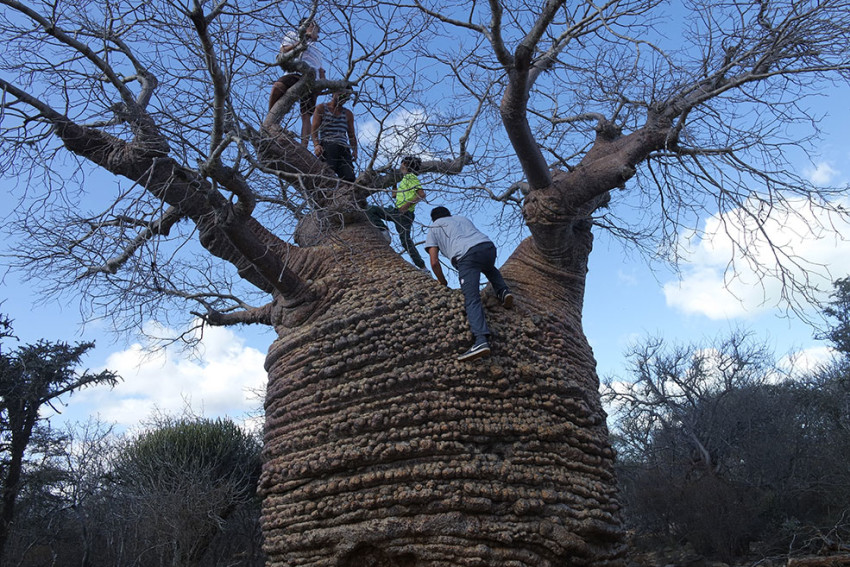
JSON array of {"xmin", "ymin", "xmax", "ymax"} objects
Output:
[{"xmin": 0, "ymin": 319, "xmax": 118, "ymax": 558}]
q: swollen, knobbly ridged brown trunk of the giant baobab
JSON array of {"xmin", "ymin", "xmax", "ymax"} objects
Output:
[{"xmin": 260, "ymin": 215, "xmax": 624, "ymax": 567}]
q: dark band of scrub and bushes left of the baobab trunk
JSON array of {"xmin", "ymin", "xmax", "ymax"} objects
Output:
[{"xmin": 4, "ymin": 416, "xmax": 265, "ymax": 567}]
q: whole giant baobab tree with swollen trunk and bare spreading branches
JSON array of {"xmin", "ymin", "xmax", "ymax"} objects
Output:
[{"xmin": 0, "ymin": 0, "xmax": 850, "ymax": 566}]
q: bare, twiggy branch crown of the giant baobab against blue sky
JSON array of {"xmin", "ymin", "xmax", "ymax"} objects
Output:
[{"xmin": 0, "ymin": 0, "xmax": 850, "ymax": 336}]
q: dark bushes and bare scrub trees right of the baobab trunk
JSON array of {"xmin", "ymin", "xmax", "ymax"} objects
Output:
[{"xmin": 606, "ymin": 279, "xmax": 850, "ymax": 561}]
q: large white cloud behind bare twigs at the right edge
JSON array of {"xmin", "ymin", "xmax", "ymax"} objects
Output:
[{"xmin": 663, "ymin": 198, "xmax": 850, "ymax": 320}]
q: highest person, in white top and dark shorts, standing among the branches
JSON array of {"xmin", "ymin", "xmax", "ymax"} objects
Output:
[{"xmin": 269, "ymin": 18, "xmax": 325, "ymax": 148}]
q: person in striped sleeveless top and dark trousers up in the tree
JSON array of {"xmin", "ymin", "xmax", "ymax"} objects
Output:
[{"xmin": 313, "ymin": 90, "xmax": 357, "ymax": 181}]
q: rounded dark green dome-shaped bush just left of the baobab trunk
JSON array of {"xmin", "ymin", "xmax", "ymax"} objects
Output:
[{"xmin": 112, "ymin": 418, "xmax": 260, "ymax": 567}]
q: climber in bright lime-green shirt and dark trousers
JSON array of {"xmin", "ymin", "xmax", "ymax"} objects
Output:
[{"xmin": 366, "ymin": 156, "xmax": 428, "ymax": 272}]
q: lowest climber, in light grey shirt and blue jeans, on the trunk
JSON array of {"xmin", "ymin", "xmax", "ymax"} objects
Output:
[{"xmin": 425, "ymin": 207, "xmax": 514, "ymax": 360}]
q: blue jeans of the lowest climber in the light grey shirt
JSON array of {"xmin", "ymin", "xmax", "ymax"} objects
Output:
[{"xmin": 453, "ymin": 242, "xmax": 508, "ymax": 343}]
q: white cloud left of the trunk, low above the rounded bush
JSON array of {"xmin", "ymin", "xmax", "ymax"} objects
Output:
[{"xmin": 72, "ymin": 327, "xmax": 266, "ymax": 426}]
